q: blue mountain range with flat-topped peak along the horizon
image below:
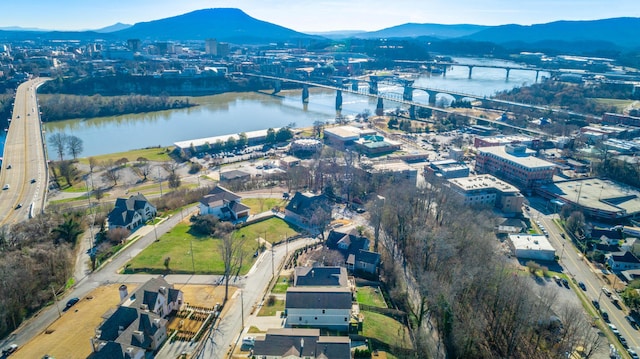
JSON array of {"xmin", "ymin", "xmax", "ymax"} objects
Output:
[{"xmin": 0, "ymin": 8, "xmax": 640, "ymax": 50}]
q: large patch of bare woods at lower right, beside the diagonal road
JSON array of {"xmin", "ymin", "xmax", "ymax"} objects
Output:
[{"xmin": 368, "ymin": 183, "xmax": 603, "ymax": 358}]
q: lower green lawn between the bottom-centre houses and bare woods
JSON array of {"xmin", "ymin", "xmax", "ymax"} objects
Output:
[{"xmin": 362, "ymin": 311, "xmax": 413, "ymax": 349}]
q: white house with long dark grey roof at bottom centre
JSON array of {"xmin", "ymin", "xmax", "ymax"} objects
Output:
[{"xmin": 285, "ymin": 286, "xmax": 353, "ymax": 331}]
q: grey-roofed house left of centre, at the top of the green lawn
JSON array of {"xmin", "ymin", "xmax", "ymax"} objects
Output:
[{"xmin": 200, "ymin": 186, "xmax": 249, "ymax": 221}]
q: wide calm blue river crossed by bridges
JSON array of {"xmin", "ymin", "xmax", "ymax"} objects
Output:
[{"xmin": 38, "ymin": 59, "xmax": 546, "ymax": 156}]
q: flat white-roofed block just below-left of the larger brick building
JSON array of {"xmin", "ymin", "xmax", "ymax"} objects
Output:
[{"xmin": 449, "ymin": 175, "xmax": 524, "ymax": 214}]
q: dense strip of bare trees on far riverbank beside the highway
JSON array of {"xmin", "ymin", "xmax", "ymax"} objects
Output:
[{"xmin": 39, "ymin": 95, "xmax": 196, "ymax": 122}]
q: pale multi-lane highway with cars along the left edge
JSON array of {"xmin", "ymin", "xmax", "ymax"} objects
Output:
[{"xmin": 0, "ymin": 78, "xmax": 48, "ymax": 226}]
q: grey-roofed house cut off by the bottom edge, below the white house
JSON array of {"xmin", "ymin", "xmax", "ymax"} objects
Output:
[{"xmin": 253, "ymin": 328, "xmax": 351, "ymax": 359}]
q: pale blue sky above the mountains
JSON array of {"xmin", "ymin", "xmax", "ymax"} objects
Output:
[{"xmin": 0, "ymin": 0, "xmax": 640, "ymax": 32}]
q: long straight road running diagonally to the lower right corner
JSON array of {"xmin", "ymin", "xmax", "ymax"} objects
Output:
[{"xmin": 531, "ymin": 200, "xmax": 640, "ymax": 358}]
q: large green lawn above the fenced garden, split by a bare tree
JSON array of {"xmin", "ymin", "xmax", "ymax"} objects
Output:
[{"xmin": 125, "ymin": 223, "xmax": 258, "ymax": 274}]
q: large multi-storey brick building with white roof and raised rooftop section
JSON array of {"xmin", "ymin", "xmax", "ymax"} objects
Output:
[{"xmin": 476, "ymin": 144, "xmax": 556, "ymax": 189}]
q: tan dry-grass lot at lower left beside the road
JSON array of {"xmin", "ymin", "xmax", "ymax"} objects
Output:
[{"xmin": 12, "ymin": 284, "xmax": 135, "ymax": 359}]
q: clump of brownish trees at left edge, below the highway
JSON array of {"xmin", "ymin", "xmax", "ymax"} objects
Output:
[{"xmin": 0, "ymin": 209, "xmax": 88, "ymax": 337}]
